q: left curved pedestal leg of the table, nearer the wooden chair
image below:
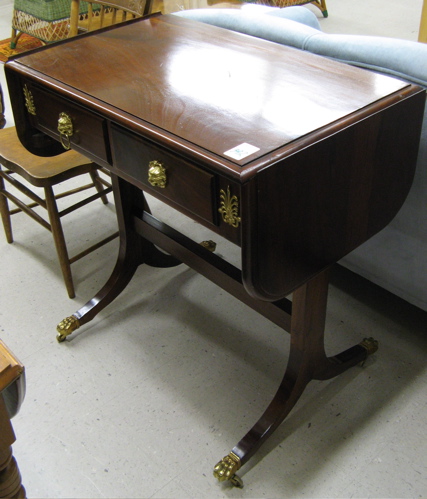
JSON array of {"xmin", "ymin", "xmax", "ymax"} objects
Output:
[{"xmin": 56, "ymin": 175, "xmax": 181, "ymax": 342}]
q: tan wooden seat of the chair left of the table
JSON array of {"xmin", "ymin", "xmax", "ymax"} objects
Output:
[{"xmin": 0, "ymin": 127, "xmax": 94, "ymax": 187}]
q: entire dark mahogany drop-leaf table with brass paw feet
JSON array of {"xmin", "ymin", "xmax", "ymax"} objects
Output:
[{"xmin": 6, "ymin": 15, "xmax": 425, "ymax": 486}]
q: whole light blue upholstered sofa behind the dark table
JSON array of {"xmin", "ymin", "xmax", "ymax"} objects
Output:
[{"xmin": 176, "ymin": 6, "xmax": 427, "ymax": 311}]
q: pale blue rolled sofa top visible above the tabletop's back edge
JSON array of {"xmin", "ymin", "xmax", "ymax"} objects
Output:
[{"xmin": 176, "ymin": 7, "xmax": 427, "ymax": 87}]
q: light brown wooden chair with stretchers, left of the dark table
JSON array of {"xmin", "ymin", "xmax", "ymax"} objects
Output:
[{"xmin": 0, "ymin": 87, "xmax": 118, "ymax": 298}]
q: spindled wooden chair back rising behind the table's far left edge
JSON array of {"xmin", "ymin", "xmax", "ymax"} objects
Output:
[{"xmin": 69, "ymin": 0, "xmax": 153, "ymax": 36}]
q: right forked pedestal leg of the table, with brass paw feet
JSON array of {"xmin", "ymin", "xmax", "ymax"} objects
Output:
[{"xmin": 214, "ymin": 271, "xmax": 377, "ymax": 487}]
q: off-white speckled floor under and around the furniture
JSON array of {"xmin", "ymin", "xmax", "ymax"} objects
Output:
[{"xmin": 0, "ymin": 0, "xmax": 427, "ymax": 498}]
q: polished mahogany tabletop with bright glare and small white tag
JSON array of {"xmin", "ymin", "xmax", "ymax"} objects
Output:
[{"xmin": 15, "ymin": 15, "xmax": 407, "ymax": 166}]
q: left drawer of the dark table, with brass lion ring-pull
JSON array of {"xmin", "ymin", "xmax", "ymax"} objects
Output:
[{"xmin": 28, "ymin": 85, "xmax": 111, "ymax": 163}]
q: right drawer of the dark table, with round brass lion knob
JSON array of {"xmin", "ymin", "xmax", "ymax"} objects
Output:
[{"xmin": 111, "ymin": 125, "xmax": 218, "ymax": 225}]
